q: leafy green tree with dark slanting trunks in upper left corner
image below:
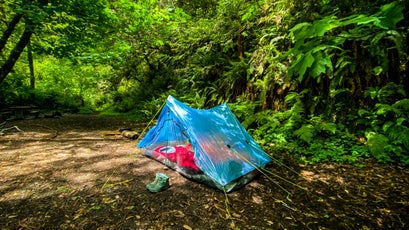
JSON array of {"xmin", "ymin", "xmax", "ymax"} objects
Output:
[{"xmin": 0, "ymin": 0, "xmax": 112, "ymax": 83}]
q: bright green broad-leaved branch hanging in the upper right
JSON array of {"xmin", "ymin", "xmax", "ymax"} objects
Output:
[{"xmin": 288, "ymin": 2, "xmax": 403, "ymax": 82}]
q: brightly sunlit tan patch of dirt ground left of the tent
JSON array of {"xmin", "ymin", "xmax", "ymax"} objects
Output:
[{"xmin": 0, "ymin": 131, "xmax": 135, "ymax": 200}]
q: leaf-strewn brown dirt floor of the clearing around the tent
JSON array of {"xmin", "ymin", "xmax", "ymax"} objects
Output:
[{"xmin": 0, "ymin": 115, "xmax": 409, "ymax": 229}]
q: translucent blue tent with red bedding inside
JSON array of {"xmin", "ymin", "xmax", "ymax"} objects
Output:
[{"xmin": 138, "ymin": 96, "xmax": 271, "ymax": 192}]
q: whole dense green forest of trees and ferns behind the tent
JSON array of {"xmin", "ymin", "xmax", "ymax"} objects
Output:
[{"xmin": 0, "ymin": 0, "xmax": 409, "ymax": 165}]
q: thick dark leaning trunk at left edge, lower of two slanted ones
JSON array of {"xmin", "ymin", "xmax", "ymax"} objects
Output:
[{"xmin": 0, "ymin": 26, "xmax": 33, "ymax": 84}]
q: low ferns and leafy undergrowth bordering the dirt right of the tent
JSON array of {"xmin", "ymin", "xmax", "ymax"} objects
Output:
[{"xmin": 232, "ymin": 85, "xmax": 409, "ymax": 165}]
